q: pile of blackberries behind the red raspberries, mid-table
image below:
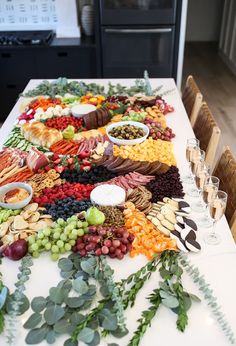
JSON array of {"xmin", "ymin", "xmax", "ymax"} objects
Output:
[{"xmin": 61, "ymin": 166, "xmax": 117, "ymax": 184}]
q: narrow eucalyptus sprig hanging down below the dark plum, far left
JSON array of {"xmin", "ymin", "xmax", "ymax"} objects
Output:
[{"xmin": 6, "ymin": 255, "xmax": 33, "ymax": 345}]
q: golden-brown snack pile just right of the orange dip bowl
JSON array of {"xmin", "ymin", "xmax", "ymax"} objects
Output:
[{"xmin": 27, "ymin": 169, "xmax": 63, "ymax": 197}]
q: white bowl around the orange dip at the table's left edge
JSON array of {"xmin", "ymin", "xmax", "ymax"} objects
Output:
[{"xmin": 0, "ymin": 182, "xmax": 33, "ymax": 209}]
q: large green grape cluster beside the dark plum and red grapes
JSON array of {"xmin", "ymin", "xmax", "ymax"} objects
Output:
[{"xmin": 28, "ymin": 215, "xmax": 88, "ymax": 261}]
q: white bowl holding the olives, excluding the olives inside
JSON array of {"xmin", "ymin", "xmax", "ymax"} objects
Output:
[{"xmin": 106, "ymin": 121, "xmax": 149, "ymax": 145}]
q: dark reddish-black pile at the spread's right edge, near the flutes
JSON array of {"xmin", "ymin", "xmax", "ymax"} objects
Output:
[{"xmin": 146, "ymin": 166, "xmax": 184, "ymax": 202}]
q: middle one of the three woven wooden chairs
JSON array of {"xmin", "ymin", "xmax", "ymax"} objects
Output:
[{"xmin": 193, "ymin": 102, "xmax": 221, "ymax": 166}]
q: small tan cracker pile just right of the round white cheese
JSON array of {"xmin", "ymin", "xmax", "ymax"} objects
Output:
[{"xmin": 127, "ymin": 186, "xmax": 152, "ymax": 214}]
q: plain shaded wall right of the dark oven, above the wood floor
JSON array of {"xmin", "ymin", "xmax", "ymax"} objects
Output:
[{"xmin": 186, "ymin": 0, "xmax": 224, "ymax": 41}]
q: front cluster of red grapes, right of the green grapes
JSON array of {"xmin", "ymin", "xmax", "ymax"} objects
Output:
[{"xmin": 72, "ymin": 226, "xmax": 134, "ymax": 260}]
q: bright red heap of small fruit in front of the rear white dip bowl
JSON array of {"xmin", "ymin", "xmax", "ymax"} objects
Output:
[{"xmin": 45, "ymin": 115, "xmax": 86, "ymax": 132}]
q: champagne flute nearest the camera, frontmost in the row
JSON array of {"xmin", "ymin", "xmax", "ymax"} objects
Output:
[{"xmin": 204, "ymin": 190, "xmax": 228, "ymax": 245}]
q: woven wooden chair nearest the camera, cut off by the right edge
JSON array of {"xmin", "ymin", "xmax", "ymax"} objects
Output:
[{"xmin": 213, "ymin": 147, "xmax": 236, "ymax": 242}]
